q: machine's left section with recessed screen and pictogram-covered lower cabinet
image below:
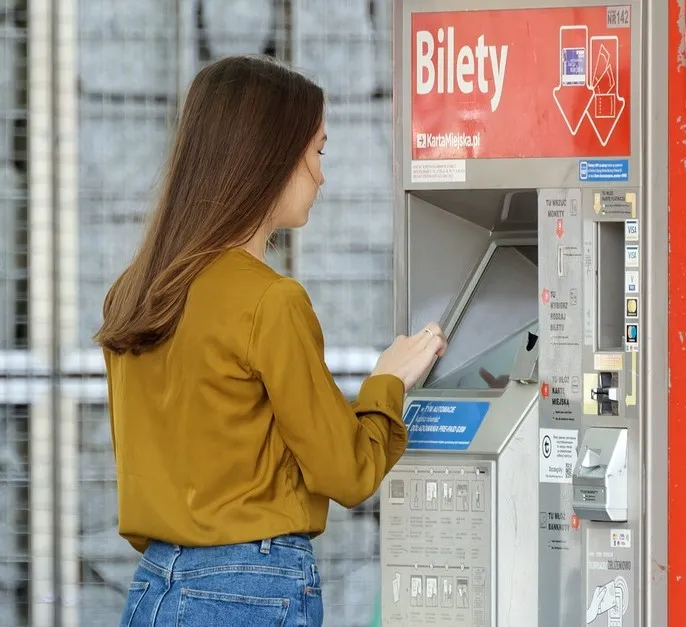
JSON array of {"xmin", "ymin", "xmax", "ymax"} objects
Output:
[{"xmin": 380, "ymin": 189, "xmax": 540, "ymax": 627}]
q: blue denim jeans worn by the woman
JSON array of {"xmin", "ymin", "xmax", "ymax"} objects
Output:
[{"xmin": 120, "ymin": 535, "xmax": 324, "ymax": 627}]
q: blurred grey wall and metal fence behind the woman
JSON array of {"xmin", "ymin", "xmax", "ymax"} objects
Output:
[{"xmin": 0, "ymin": 0, "xmax": 392, "ymax": 627}]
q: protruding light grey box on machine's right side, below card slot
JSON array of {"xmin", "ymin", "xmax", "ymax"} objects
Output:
[{"xmin": 572, "ymin": 427, "xmax": 628, "ymax": 522}]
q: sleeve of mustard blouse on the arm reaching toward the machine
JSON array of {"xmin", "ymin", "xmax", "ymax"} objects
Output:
[{"xmin": 248, "ymin": 278, "xmax": 407, "ymax": 507}]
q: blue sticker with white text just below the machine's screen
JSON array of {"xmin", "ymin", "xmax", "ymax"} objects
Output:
[{"xmin": 403, "ymin": 401, "xmax": 490, "ymax": 451}]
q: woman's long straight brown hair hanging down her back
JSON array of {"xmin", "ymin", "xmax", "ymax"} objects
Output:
[{"xmin": 94, "ymin": 57, "xmax": 324, "ymax": 354}]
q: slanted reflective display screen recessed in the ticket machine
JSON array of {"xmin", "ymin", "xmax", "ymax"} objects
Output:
[{"xmin": 424, "ymin": 246, "xmax": 538, "ymax": 390}]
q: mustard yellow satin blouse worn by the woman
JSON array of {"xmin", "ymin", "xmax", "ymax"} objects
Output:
[{"xmin": 105, "ymin": 249, "xmax": 407, "ymax": 551}]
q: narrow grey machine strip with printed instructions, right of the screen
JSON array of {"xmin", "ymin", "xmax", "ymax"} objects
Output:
[{"xmin": 538, "ymin": 189, "xmax": 583, "ymax": 627}]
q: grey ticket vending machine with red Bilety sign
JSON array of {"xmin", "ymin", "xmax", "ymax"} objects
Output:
[{"xmin": 381, "ymin": 0, "xmax": 667, "ymax": 627}]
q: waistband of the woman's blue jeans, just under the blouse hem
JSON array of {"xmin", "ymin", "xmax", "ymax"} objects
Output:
[{"xmin": 143, "ymin": 534, "xmax": 313, "ymax": 572}]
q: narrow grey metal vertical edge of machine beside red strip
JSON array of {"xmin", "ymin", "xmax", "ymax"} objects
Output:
[{"xmin": 639, "ymin": 0, "xmax": 672, "ymax": 627}]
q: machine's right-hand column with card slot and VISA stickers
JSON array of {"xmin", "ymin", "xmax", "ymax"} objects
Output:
[{"xmin": 575, "ymin": 185, "xmax": 653, "ymax": 627}]
